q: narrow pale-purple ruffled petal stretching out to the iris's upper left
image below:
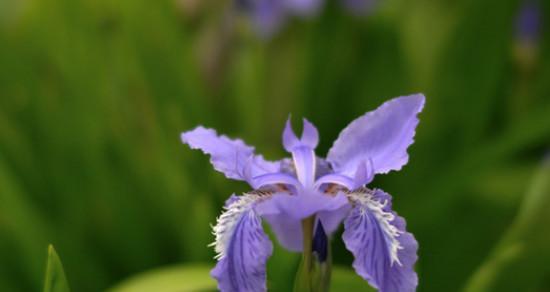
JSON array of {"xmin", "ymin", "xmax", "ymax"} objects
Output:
[{"xmin": 181, "ymin": 126, "xmax": 280, "ymax": 180}]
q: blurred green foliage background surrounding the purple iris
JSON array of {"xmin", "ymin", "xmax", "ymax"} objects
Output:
[{"xmin": 0, "ymin": 0, "xmax": 550, "ymax": 292}]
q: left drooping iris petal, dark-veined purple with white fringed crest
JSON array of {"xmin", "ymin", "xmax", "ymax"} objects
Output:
[{"xmin": 211, "ymin": 194, "xmax": 273, "ymax": 292}]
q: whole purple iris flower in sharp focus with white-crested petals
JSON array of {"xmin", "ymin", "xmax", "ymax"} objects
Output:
[{"xmin": 181, "ymin": 94, "xmax": 424, "ymax": 292}]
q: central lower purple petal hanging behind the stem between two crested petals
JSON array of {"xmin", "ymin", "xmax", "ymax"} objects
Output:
[{"xmin": 256, "ymin": 191, "xmax": 348, "ymax": 251}]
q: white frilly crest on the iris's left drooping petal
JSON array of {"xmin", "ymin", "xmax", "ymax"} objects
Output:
[{"xmin": 210, "ymin": 191, "xmax": 269, "ymax": 259}]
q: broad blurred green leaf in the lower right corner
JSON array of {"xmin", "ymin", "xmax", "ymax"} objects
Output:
[{"xmin": 465, "ymin": 160, "xmax": 550, "ymax": 292}]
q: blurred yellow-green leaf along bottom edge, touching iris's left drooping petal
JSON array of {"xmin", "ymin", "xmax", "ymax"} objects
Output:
[{"xmin": 108, "ymin": 265, "xmax": 216, "ymax": 292}]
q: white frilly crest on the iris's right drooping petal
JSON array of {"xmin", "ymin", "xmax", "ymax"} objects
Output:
[{"xmin": 348, "ymin": 188, "xmax": 403, "ymax": 266}]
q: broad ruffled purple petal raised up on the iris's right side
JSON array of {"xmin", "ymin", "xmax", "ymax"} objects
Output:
[{"xmin": 327, "ymin": 94, "xmax": 424, "ymax": 177}]
